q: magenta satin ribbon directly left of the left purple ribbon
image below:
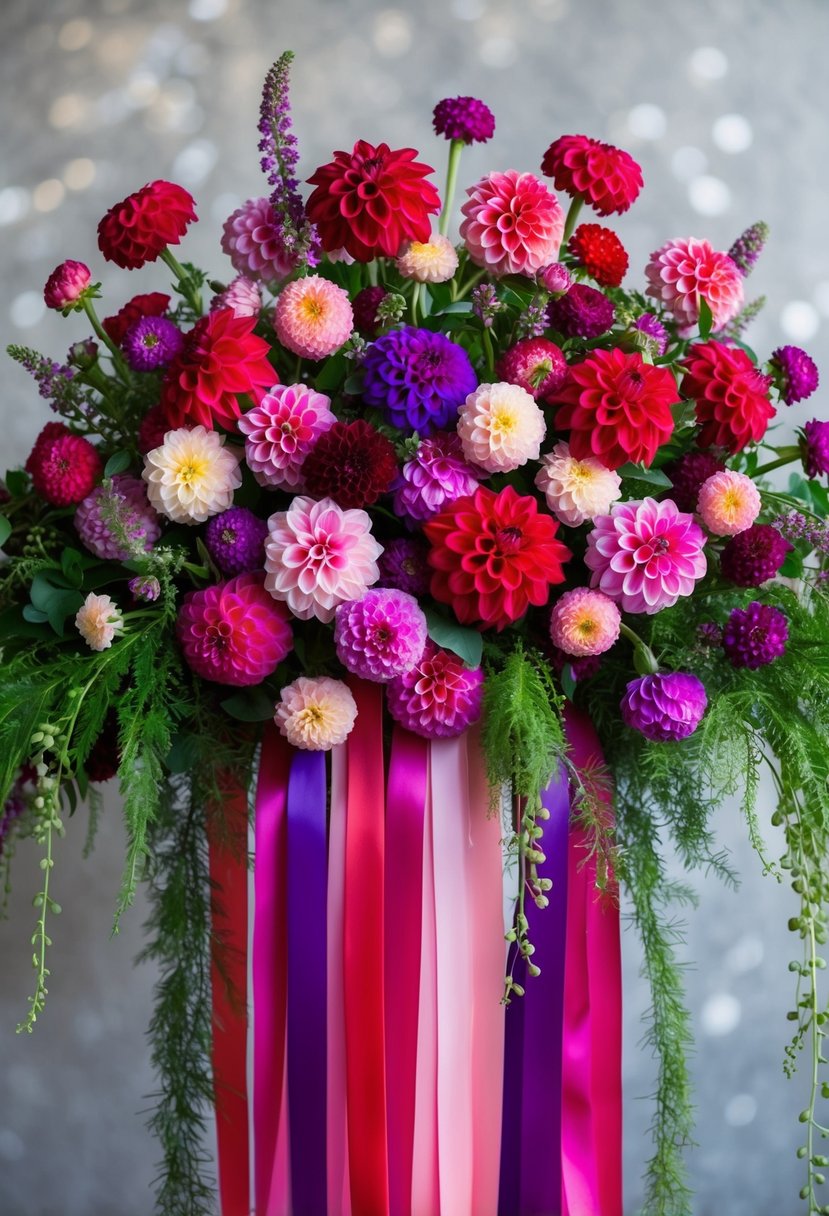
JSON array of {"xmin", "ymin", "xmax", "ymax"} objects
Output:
[{"xmin": 253, "ymin": 724, "xmax": 291, "ymax": 1216}]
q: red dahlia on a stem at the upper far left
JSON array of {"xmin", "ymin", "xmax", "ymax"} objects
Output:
[{"xmin": 98, "ymin": 181, "xmax": 196, "ymax": 270}]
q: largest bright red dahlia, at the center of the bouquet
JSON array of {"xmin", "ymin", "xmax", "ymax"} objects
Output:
[{"xmin": 423, "ymin": 485, "xmax": 570, "ymax": 630}]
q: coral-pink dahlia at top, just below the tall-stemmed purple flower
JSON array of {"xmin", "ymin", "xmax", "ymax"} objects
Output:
[{"xmin": 461, "ymin": 169, "xmax": 564, "ymax": 275}]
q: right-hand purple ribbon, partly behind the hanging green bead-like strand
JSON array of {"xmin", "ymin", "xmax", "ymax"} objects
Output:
[{"xmin": 498, "ymin": 769, "xmax": 570, "ymax": 1216}]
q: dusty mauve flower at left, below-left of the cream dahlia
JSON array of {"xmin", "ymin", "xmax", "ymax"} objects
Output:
[{"xmin": 75, "ymin": 473, "xmax": 162, "ymax": 562}]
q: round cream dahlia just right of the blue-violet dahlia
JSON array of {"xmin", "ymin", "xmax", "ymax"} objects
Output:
[{"xmin": 457, "ymin": 381, "xmax": 547, "ymax": 473}]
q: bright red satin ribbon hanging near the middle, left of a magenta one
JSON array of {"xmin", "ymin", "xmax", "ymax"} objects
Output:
[{"xmin": 343, "ymin": 680, "xmax": 389, "ymax": 1216}]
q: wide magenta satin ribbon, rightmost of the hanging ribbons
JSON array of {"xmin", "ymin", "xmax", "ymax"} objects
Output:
[{"xmin": 562, "ymin": 705, "xmax": 622, "ymax": 1216}]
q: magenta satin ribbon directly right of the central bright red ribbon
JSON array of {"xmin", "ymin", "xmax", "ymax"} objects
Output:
[{"xmin": 385, "ymin": 726, "xmax": 429, "ymax": 1216}]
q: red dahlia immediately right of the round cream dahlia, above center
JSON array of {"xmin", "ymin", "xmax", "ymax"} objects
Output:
[{"xmin": 556, "ymin": 349, "xmax": 679, "ymax": 468}]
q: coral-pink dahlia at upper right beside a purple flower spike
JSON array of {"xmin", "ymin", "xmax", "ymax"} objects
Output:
[{"xmin": 645, "ymin": 237, "xmax": 743, "ymax": 330}]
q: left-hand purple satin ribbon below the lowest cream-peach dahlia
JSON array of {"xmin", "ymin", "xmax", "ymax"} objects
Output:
[{"xmin": 287, "ymin": 751, "xmax": 328, "ymax": 1216}]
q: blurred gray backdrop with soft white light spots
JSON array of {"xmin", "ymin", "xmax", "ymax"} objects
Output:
[{"xmin": 0, "ymin": 0, "xmax": 829, "ymax": 1216}]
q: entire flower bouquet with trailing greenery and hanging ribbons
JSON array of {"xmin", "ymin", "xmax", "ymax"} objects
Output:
[{"xmin": 0, "ymin": 55, "xmax": 829, "ymax": 1216}]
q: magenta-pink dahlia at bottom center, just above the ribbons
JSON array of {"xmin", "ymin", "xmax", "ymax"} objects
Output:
[{"xmin": 387, "ymin": 641, "xmax": 484, "ymax": 739}]
